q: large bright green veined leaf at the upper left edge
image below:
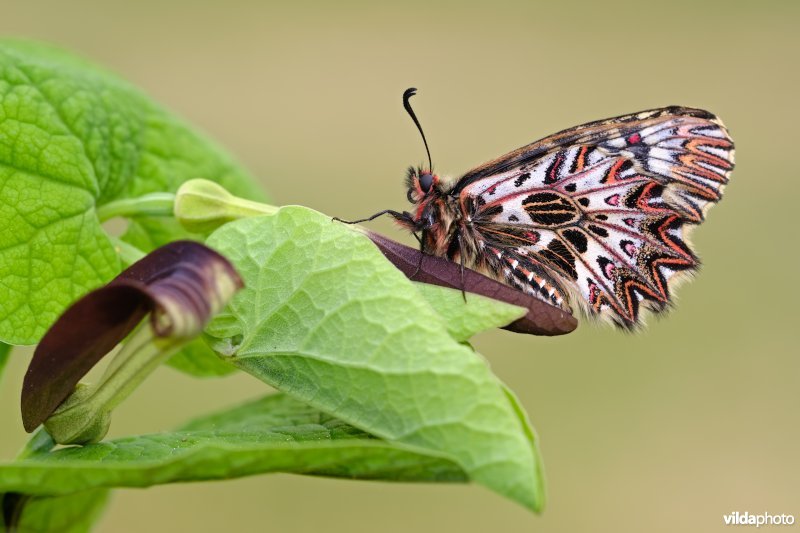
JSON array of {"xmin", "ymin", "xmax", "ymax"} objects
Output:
[{"xmin": 0, "ymin": 40, "xmax": 261, "ymax": 344}]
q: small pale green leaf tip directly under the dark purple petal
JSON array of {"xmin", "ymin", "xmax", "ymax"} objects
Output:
[{"xmin": 414, "ymin": 283, "xmax": 527, "ymax": 341}]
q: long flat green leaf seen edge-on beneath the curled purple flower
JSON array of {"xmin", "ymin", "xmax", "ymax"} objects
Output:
[{"xmin": 0, "ymin": 394, "xmax": 466, "ymax": 495}]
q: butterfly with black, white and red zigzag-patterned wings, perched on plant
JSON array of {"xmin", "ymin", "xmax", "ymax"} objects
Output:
[{"xmin": 340, "ymin": 88, "xmax": 734, "ymax": 329}]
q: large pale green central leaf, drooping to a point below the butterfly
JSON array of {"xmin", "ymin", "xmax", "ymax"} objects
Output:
[{"xmin": 206, "ymin": 207, "xmax": 543, "ymax": 510}]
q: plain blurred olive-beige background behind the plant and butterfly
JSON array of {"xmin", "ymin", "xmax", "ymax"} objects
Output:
[{"xmin": 0, "ymin": 0, "xmax": 800, "ymax": 533}]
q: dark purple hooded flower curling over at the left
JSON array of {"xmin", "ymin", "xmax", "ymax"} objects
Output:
[{"xmin": 22, "ymin": 241, "xmax": 242, "ymax": 443}]
